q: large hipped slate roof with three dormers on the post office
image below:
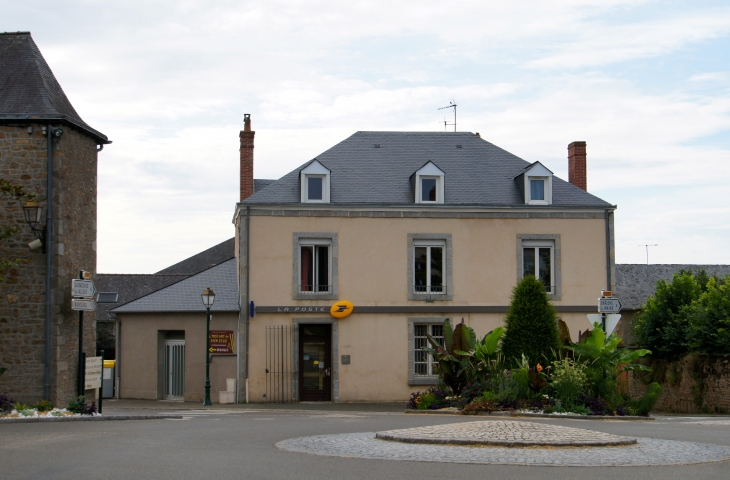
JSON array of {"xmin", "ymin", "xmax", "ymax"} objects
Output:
[{"xmin": 242, "ymin": 132, "xmax": 612, "ymax": 208}]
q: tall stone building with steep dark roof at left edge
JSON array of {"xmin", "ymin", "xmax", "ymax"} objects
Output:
[{"xmin": 0, "ymin": 32, "xmax": 111, "ymax": 405}]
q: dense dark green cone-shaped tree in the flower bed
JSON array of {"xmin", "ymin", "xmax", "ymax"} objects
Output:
[{"xmin": 502, "ymin": 275, "xmax": 562, "ymax": 365}]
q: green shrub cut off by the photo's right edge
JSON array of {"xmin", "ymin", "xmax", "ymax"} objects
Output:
[{"xmin": 685, "ymin": 278, "xmax": 730, "ymax": 355}]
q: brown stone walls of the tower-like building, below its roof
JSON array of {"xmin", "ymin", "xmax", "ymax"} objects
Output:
[{"xmin": 0, "ymin": 124, "xmax": 97, "ymax": 406}]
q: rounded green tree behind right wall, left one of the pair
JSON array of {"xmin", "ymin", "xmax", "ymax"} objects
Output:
[{"xmin": 631, "ymin": 271, "xmax": 702, "ymax": 360}]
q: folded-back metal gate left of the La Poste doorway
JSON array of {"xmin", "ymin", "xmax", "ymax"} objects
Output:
[{"xmin": 266, "ymin": 325, "xmax": 294, "ymax": 403}]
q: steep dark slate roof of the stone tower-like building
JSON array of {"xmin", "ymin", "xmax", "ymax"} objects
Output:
[{"xmin": 0, "ymin": 32, "xmax": 111, "ymax": 144}]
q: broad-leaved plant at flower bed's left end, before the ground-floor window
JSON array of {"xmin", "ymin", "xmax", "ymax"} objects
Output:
[{"xmin": 423, "ymin": 318, "xmax": 476, "ymax": 396}]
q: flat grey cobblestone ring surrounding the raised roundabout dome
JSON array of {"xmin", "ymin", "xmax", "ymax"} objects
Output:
[{"xmin": 276, "ymin": 424, "xmax": 730, "ymax": 467}]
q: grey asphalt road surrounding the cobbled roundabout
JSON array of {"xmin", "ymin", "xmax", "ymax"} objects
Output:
[{"xmin": 0, "ymin": 410, "xmax": 730, "ymax": 480}]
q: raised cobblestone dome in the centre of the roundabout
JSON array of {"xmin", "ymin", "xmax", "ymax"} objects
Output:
[{"xmin": 375, "ymin": 421, "xmax": 636, "ymax": 447}]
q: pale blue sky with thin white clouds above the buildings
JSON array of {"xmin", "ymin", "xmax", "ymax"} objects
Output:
[{"xmin": 0, "ymin": 0, "xmax": 730, "ymax": 273}]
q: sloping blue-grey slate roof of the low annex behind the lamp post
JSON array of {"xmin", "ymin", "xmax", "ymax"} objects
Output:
[{"xmin": 112, "ymin": 259, "xmax": 239, "ymax": 314}]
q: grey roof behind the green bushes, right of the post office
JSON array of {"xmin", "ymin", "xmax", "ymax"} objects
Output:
[{"xmin": 614, "ymin": 264, "xmax": 730, "ymax": 310}]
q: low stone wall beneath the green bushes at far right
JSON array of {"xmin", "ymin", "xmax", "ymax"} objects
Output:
[{"xmin": 629, "ymin": 355, "xmax": 730, "ymax": 413}]
